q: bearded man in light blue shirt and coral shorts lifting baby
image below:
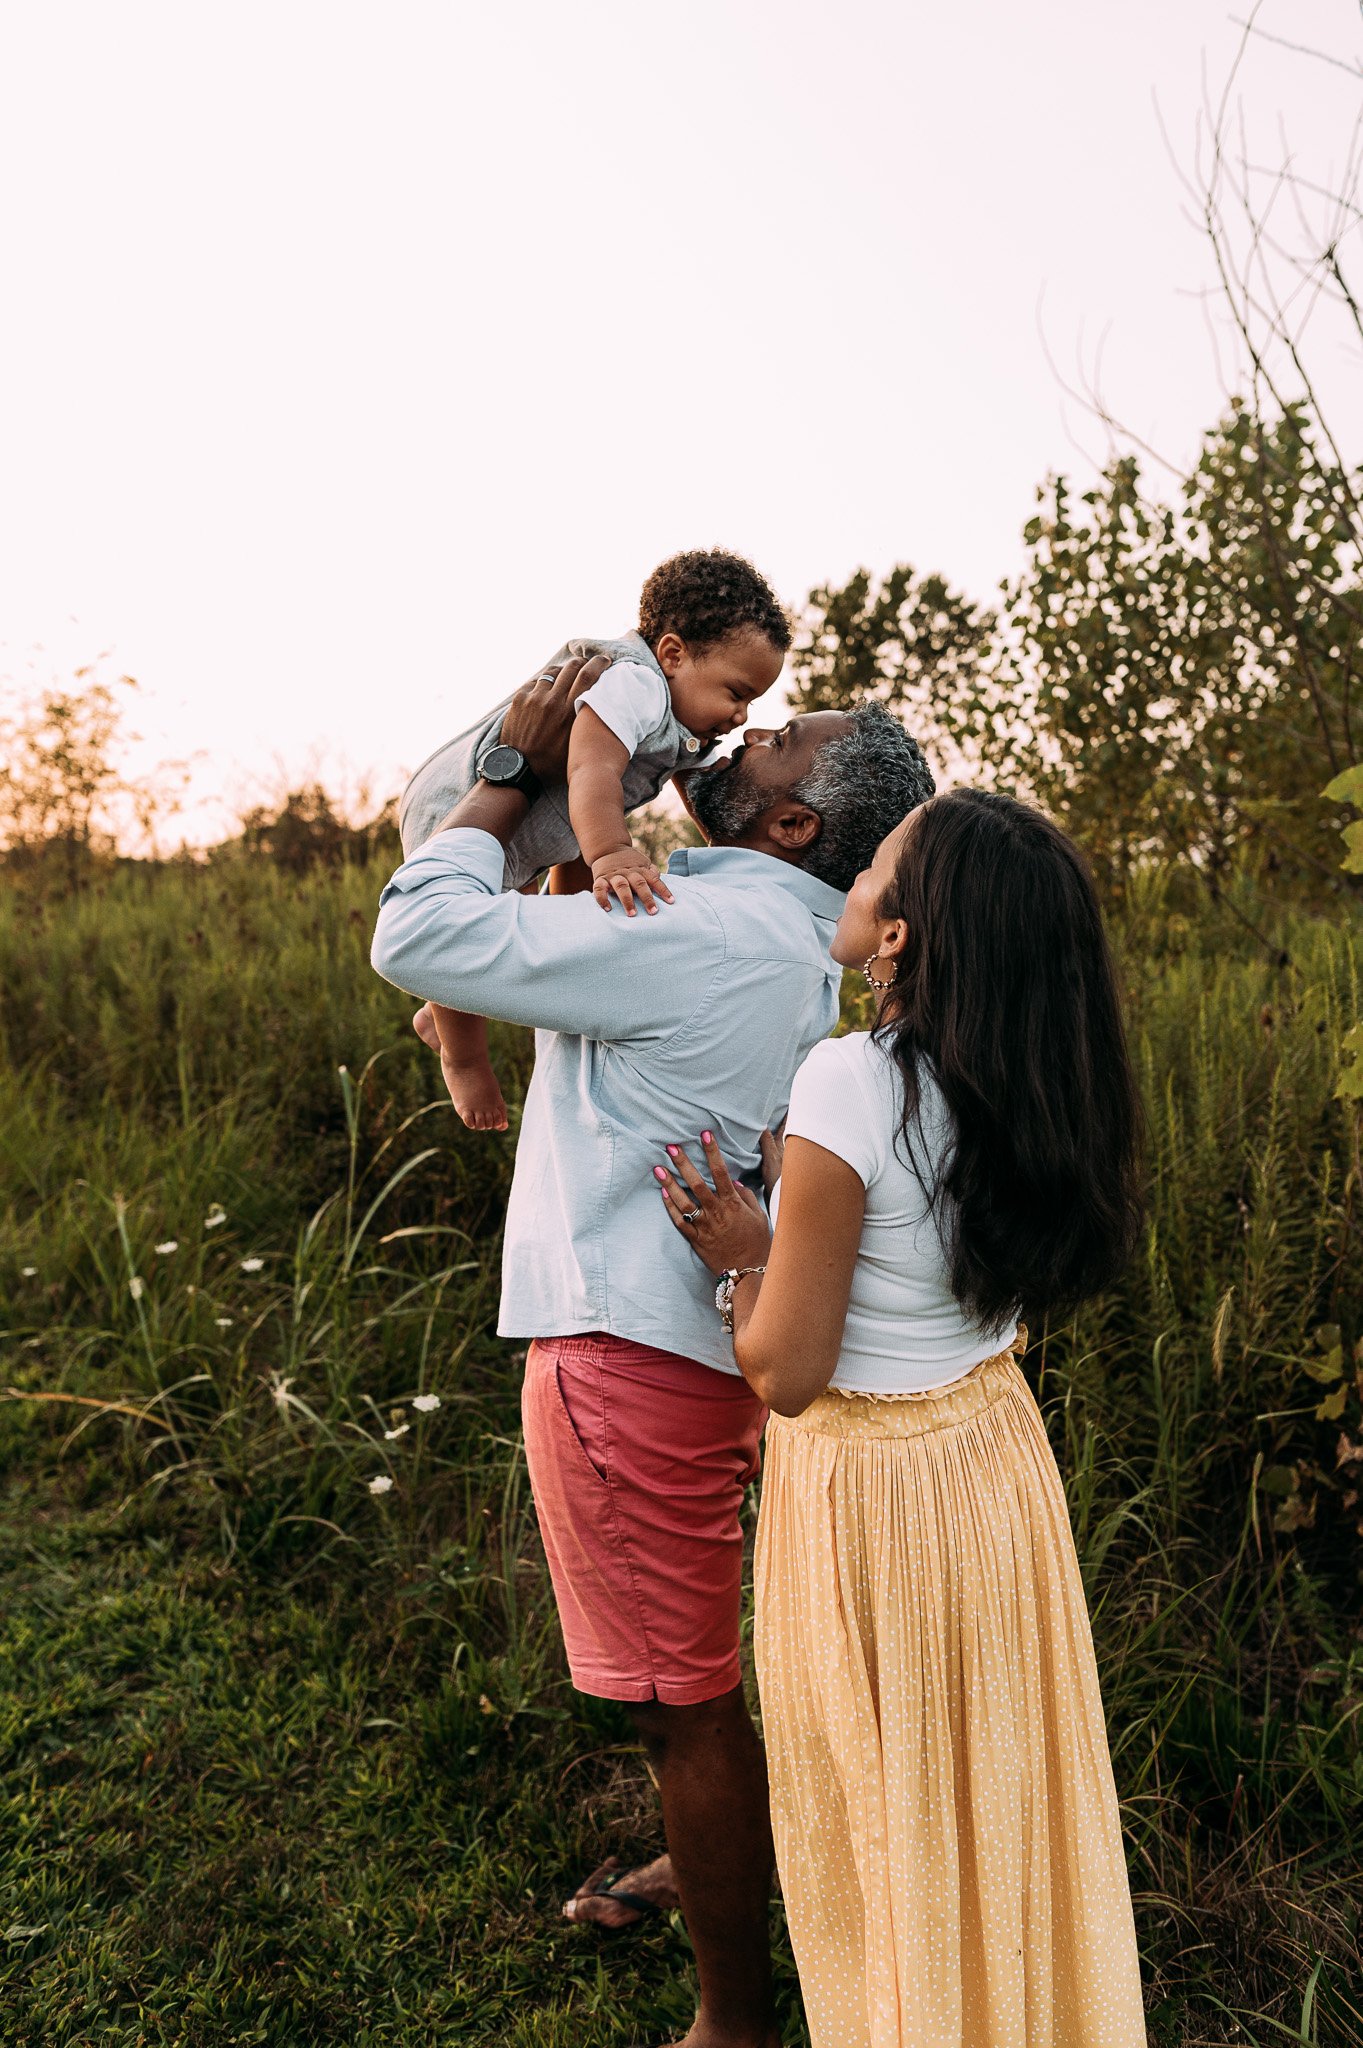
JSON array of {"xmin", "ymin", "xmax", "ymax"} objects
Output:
[{"xmin": 372, "ymin": 662, "xmax": 933, "ymax": 2048}]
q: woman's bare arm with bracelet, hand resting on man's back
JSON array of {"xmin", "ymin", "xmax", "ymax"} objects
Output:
[{"xmin": 657, "ymin": 1133, "xmax": 866, "ymax": 1415}]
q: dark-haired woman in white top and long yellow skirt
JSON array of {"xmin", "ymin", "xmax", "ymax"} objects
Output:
[{"xmin": 657, "ymin": 791, "xmax": 1146, "ymax": 2048}]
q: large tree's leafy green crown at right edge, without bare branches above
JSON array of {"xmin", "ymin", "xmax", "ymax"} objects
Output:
[{"xmin": 1003, "ymin": 401, "xmax": 1363, "ymax": 893}]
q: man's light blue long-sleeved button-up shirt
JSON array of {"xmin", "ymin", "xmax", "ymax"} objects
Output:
[{"xmin": 372, "ymin": 829, "xmax": 843, "ymax": 1372}]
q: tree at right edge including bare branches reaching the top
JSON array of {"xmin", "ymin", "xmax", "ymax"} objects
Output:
[{"xmin": 1013, "ymin": 0, "xmax": 1363, "ymax": 893}]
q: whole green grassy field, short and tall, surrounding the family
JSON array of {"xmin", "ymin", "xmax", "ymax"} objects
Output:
[{"xmin": 0, "ymin": 862, "xmax": 1363, "ymax": 2048}]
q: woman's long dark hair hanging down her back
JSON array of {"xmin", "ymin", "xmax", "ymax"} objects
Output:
[{"xmin": 863, "ymin": 788, "xmax": 1142, "ymax": 1329}]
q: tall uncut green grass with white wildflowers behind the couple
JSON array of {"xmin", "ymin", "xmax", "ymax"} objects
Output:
[{"xmin": 0, "ymin": 862, "xmax": 1363, "ymax": 2044}]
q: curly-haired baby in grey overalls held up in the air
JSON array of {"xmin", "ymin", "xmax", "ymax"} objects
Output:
[{"xmin": 399, "ymin": 551, "xmax": 790, "ymax": 1130}]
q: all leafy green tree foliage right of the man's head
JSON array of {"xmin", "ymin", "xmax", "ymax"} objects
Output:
[{"xmin": 792, "ymin": 403, "xmax": 1363, "ymax": 901}]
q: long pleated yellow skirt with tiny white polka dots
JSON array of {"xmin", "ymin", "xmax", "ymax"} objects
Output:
[{"xmin": 757, "ymin": 1354, "xmax": 1146, "ymax": 2048}]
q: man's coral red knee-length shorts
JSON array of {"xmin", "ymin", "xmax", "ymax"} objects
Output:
[{"xmin": 522, "ymin": 1331, "xmax": 767, "ymax": 1706}]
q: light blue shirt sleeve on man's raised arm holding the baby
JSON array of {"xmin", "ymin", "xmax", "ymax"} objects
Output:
[{"xmin": 370, "ymin": 827, "xmax": 724, "ymax": 1044}]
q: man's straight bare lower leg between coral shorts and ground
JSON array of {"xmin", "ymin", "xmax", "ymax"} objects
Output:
[{"xmin": 630, "ymin": 1686, "xmax": 780, "ymax": 2048}]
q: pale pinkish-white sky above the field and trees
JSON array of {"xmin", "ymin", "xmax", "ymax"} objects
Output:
[{"xmin": 0, "ymin": 0, "xmax": 1363, "ymax": 834}]
